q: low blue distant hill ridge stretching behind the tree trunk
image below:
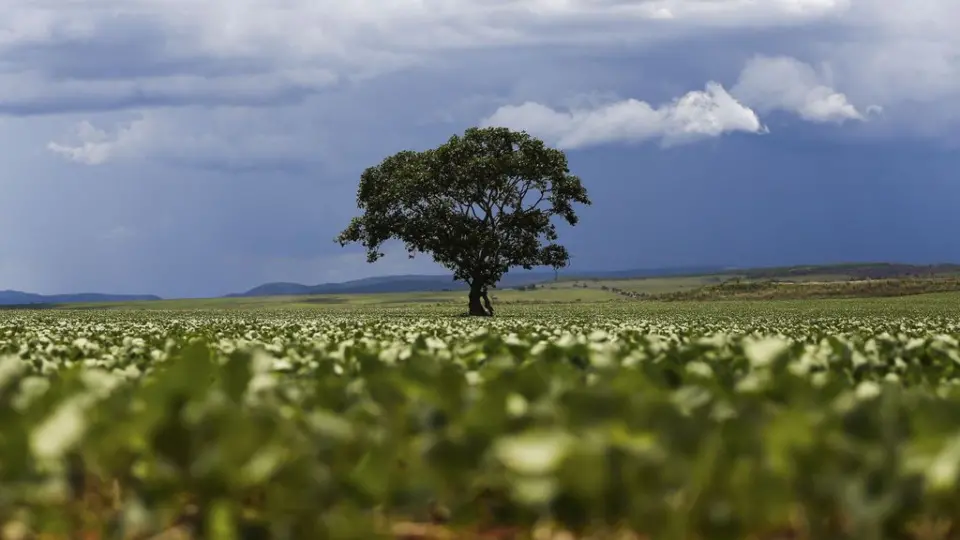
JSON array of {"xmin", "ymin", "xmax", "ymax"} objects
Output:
[{"xmin": 226, "ymin": 266, "xmax": 726, "ymax": 298}]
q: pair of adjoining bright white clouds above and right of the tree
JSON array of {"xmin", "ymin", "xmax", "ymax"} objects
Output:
[{"xmin": 480, "ymin": 56, "xmax": 875, "ymax": 149}]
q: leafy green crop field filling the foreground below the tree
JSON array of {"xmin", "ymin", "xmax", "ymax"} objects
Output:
[{"xmin": 0, "ymin": 294, "xmax": 960, "ymax": 540}]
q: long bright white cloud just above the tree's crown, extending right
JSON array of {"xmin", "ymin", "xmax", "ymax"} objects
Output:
[{"xmin": 481, "ymin": 82, "xmax": 766, "ymax": 148}]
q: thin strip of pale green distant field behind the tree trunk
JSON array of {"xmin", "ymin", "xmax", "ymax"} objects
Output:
[{"xmin": 18, "ymin": 264, "xmax": 960, "ymax": 309}]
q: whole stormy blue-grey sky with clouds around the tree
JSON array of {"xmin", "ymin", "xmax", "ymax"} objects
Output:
[{"xmin": 0, "ymin": 0, "xmax": 960, "ymax": 297}]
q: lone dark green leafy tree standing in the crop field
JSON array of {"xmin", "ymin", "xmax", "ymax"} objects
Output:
[{"xmin": 336, "ymin": 127, "xmax": 590, "ymax": 316}]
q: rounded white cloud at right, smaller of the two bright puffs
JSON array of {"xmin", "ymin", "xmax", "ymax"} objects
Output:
[{"xmin": 731, "ymin": 56, "xmax": 865, "ymax": 123}]
